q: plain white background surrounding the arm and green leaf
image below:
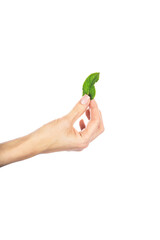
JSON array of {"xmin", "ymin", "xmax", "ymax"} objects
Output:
[{"xmin": 0, "ymin": 0, "xmax": 160, "ymax": 240}]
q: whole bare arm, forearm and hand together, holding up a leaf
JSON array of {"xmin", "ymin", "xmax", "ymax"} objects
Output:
[{"xmin": 0, "ymin": 95, "xmax": 104, "ymax": 167}]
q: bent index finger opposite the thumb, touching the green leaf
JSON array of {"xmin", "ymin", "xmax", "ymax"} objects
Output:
[{"xmin": 81, "ymin": 99, "xmax": 104, "ymax": 141}]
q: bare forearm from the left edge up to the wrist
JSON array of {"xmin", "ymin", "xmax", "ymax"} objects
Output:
[{"xmin": 0, "ymin": 132, "xmax": 41, "ymax": 167}]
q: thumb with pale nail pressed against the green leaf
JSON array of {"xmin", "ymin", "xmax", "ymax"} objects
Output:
[{"xmin": 68, "ymin": 94, "xmax": 90, "ymax": 123}]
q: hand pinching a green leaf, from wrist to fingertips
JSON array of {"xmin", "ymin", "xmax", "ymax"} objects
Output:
[{"xmin": 35, "ymin": 95, "xmax": 104, "ymax": 153}]
